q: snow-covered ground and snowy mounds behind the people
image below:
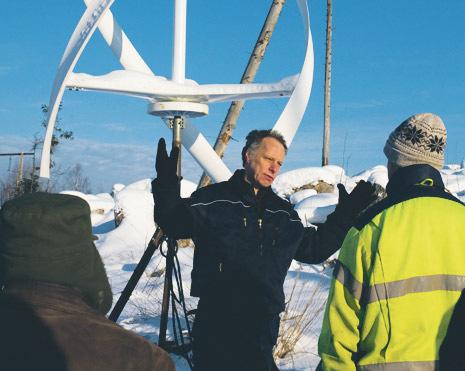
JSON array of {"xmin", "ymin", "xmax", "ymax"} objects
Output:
[{"xmin": 65, "ymin": 160, "xmax": 465, "ymax": 370}]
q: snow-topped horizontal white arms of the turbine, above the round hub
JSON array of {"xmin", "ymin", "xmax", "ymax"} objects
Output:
[{"xmin": 66, "ymin": 70, "xmax": 297, "ymax": 103}]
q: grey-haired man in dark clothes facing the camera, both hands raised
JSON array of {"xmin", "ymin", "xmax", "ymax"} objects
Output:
[{"xmin": 152, "ymin": 130, "xmax": 375, "ymax": 371}]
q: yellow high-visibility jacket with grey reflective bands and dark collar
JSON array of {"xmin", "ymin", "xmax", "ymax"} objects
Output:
[{"xmin": 318, "ymin": 165, "xmax": 465, "ymax": 371}]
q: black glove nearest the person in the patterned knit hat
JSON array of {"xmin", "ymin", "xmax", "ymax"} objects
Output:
[{"xmin": 337, "ymin": 180, "xmax": 378, "ymax": 217}]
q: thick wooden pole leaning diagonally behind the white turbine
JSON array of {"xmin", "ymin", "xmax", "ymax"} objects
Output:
[{"xmin": 199, "ymin": 0, "xmax": 286, "ymax": 188}]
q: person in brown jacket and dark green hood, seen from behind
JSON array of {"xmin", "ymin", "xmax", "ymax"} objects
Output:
[{"xmin": 0, "ymin": 192, "xmax": 175, "ymax": 371}]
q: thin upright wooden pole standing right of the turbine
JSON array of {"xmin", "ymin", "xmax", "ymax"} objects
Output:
[{"xmin": 321, "ymin": 0, "xmax": 333, "ymax": 166}]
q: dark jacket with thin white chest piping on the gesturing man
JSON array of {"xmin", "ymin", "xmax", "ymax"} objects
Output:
[{"xmin": 152, "ymin": 170, "xmax": 350, "ymax": 314}]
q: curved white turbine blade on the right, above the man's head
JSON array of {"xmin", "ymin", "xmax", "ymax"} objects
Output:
[{"xmin": 273, "ymin": 0, "xmax": 314, "ymax": 145}]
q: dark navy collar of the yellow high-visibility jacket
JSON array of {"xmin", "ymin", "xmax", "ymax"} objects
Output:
[{"xmin": 386, "ymin": 164, "xmax": 444, "ymax": 195}]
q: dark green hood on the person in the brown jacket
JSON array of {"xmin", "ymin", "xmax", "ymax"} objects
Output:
[{"xmin": 0, "ymin": 192, "xmax": 112, "ymax": 313}]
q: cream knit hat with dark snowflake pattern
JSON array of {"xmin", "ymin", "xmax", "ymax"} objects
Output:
[{"xmin": 384, "ymin": 113, "xmax": 447, "ymax": 170}]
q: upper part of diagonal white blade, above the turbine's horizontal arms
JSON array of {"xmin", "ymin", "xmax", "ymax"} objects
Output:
[{"xmin": 84, "ymin": 0, "xmax": 154, "ymax": 75}]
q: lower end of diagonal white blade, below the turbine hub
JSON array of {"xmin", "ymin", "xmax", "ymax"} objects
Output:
[{"xmin": 163, "ymin": 118, "xmax": 232, "ymax": 183}]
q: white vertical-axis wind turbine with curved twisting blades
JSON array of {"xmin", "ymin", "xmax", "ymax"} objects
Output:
[{"xmin": 40, "ymin": 0, "xmax": 313, "ymax": 182}]
